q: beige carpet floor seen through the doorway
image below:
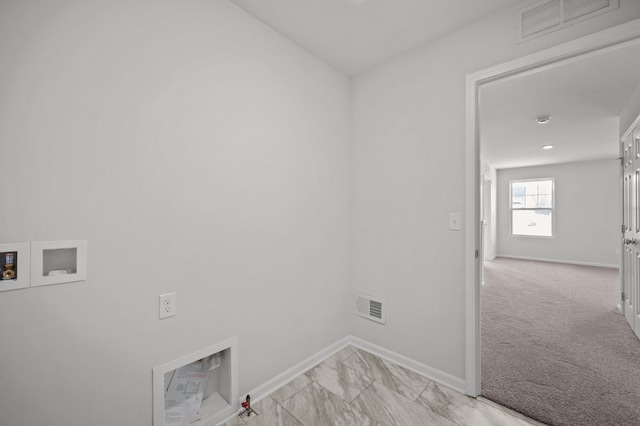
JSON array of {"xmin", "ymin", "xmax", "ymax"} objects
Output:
[{"xmin": 481, "ymin": 258, "xmax": 640, "ymax": 426}]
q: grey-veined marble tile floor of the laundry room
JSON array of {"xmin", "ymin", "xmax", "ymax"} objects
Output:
[{"xmin": 225, "ymin": 346, "xmax": 541, "ymax": 426}]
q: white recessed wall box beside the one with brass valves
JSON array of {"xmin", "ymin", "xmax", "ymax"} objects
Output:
[{"xmin": 31, "ymin": 240, "xmax": 87, "ymax": 286}]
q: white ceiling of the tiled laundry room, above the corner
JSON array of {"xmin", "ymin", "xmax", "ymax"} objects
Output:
[{"xmin": 231, "ymin": 0, "xmax": 522, "ymax": 76}]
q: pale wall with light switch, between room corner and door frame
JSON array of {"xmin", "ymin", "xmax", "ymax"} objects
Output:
[{"xmin": 352, "ymin": 0, "xmax": 640, "ymax": 380}]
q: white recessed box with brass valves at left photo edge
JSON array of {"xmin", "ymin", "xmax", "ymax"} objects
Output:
[{"xmin": 0, "ymin": 243, "xmax": 31, "ymax": 291}]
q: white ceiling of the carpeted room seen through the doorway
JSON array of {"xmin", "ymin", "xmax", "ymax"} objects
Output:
[{"xmin": 480, "ymin": 43, "xmax": 640, "ymax": 169}]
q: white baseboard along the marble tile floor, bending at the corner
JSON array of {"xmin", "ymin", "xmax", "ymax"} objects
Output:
[{"xmin": 219, "ymin": 336, "xmax": 465, "ymax": 425}]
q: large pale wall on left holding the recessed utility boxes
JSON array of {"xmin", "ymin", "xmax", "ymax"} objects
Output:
[{"xmin": 0, "ymin": 0, "xmax": 351, "ymax": 426}]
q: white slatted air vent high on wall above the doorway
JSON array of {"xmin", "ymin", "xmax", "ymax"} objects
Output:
[{"xmin": 516, "ymin": 0, "xmax": 620, "ymax": 42}]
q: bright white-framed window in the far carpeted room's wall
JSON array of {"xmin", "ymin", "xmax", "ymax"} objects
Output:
[{"xmin": 509, "ymin": 179, "xmax": 553, "ymax": 237}]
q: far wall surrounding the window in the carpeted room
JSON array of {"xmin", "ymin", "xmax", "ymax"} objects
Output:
[{"xmin": 497, "ymin": 159, "xmax": 621, "ymax": 267}]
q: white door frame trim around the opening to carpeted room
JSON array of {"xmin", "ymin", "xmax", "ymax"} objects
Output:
[{"xmin": 464, "ymin": 19, "xmax": 640, "ymax": 397}]
